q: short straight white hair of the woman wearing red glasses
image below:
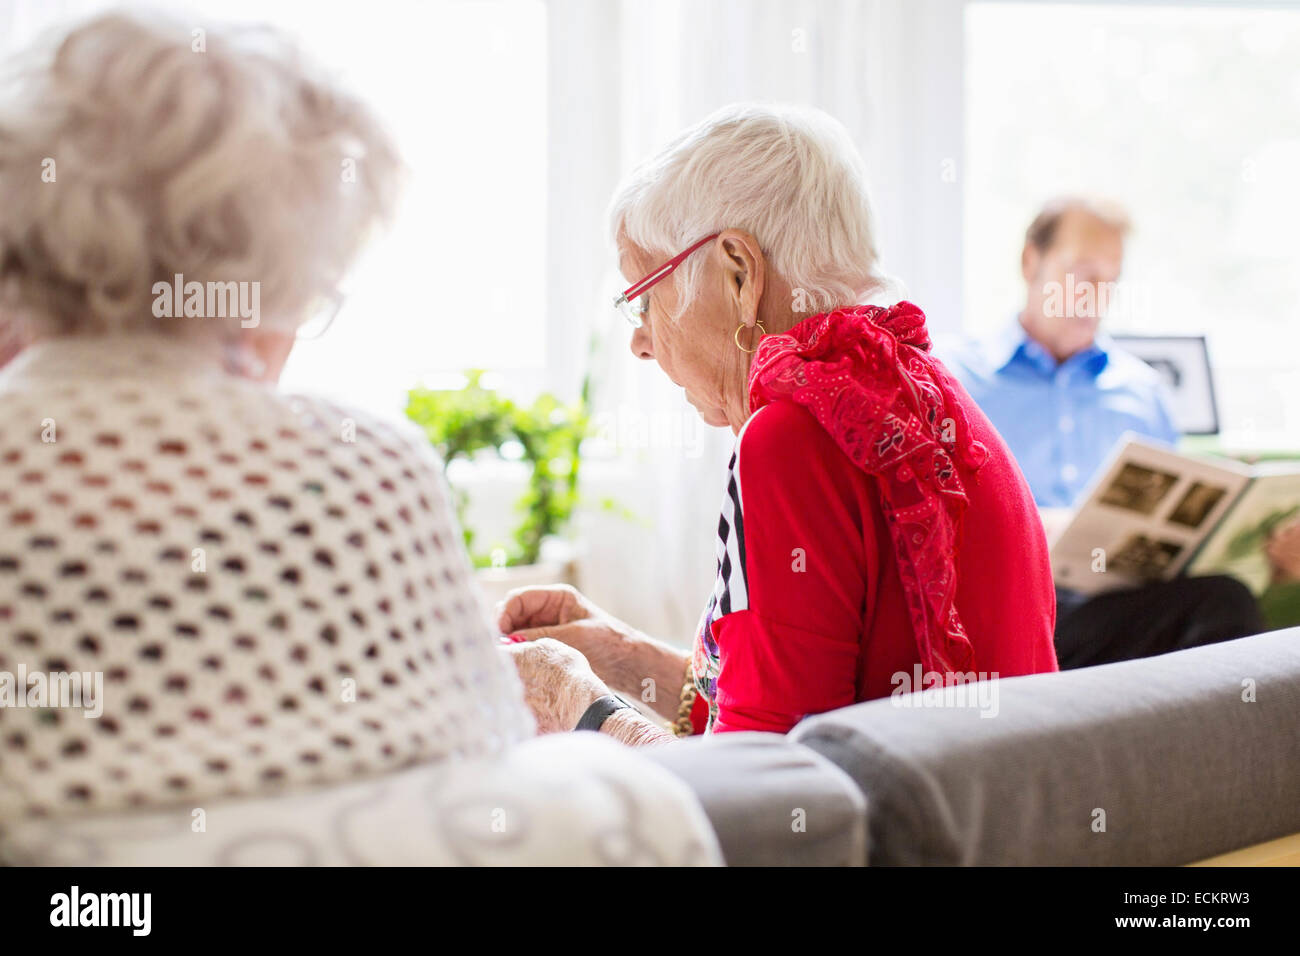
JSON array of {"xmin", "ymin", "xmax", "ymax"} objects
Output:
[{"xmin": 610, "ymin": 103, "xmax": 888, "ymax": 311}]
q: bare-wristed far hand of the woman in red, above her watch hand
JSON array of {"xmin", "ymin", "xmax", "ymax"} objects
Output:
[{"xmin": 497, "ymin": 584, "xmax": 640, "ymax": 689}]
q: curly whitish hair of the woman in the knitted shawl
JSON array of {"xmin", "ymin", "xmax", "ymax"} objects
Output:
[{"xmin": 0, "ymin": 13, "xmax": 402, "ymax": 336}]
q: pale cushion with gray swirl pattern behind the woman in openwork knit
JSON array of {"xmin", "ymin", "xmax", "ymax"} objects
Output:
[{"xmin": 0, "ymin": 734, "xmax": 722, "ymax": 866}]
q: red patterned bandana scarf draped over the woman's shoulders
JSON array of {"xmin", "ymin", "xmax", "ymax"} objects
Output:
[{"xmin": 749, "ymin": 302, "xmax": 988, "ymax": 683}]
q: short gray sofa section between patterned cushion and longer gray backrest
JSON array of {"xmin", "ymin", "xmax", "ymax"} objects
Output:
[{"xmin": 644, "ymin": 732, "xmax": 867, "ymax": 866}]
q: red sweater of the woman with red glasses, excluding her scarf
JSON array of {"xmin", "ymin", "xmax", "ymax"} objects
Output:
[{"xmin": 693, "ymin": 390, "xmax": 1057, "ymax": 734}]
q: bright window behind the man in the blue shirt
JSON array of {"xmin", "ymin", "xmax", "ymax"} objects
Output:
[{"xmin": 963, "ymin": 3, "xmax": 1300, "ymax": 446}]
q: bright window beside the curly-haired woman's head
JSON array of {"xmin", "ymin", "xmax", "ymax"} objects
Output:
[{"xmin": 263, "ymin": 0, "xmax": 547, "ymax": 414}]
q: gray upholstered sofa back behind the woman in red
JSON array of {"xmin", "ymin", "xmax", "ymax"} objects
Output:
[{"xmin": 655, "ymin": 630, "xmax": 1300, "ymax": 865}]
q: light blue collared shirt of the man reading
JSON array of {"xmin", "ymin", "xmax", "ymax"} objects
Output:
[{"xmin": 940, "ymin": 323, "xmax": 1179, "ymax": 507}]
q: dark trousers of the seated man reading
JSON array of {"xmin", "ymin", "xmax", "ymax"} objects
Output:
[{"xmin": 1056, "ymin": 576, "xmax": 1265, "ymax": 670}]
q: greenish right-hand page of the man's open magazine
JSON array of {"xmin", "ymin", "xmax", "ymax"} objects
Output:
[{"xmin": 1188, "ymin": 464, "xmax": 1300, "ymax": 627}]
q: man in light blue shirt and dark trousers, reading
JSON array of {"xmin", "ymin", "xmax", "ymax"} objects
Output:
[{"xmin": 943, "ymin": 198, "xmax": 1264, "ymax": 667}]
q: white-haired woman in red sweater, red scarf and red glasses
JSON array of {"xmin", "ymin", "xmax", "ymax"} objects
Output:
[{"xmin": 498, "ymin": 105, "xmax": 1056, "ymax": 743}]
